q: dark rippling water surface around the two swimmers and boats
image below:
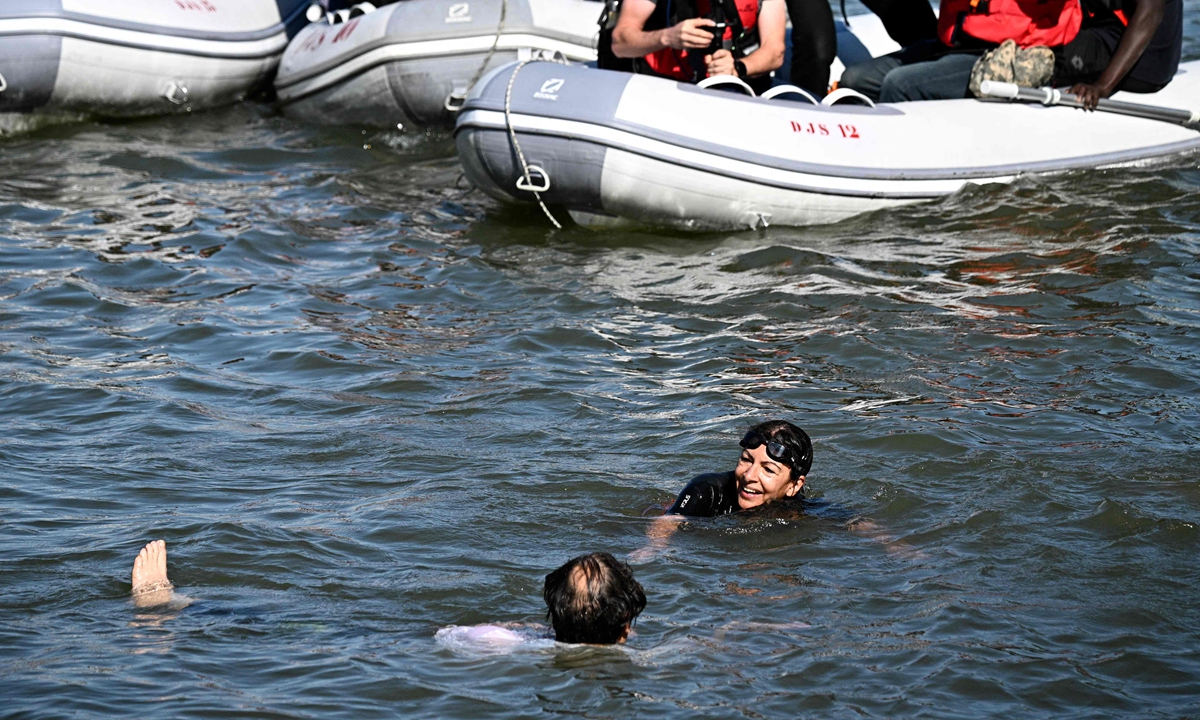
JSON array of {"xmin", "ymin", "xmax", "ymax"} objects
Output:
[{"xmin": 0, "ymin": 37, "xmax": 1200, "ymax": 719}]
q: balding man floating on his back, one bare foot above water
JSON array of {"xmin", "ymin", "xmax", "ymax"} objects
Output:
[{"xmin": 131, "ymin": 540, "xmax": 646, "ymax": 647}]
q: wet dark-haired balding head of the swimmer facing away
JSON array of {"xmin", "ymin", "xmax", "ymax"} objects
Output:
[{"xmin": 542, "ymin": 552, "xmax": 646, "ymax": 644}]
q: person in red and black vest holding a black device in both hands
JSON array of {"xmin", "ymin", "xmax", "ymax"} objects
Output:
[{"xmin": 612, "ymin": 0, "xmax": 787, "ymax": 90}]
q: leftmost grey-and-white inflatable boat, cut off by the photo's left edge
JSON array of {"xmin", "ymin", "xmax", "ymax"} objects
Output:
[{"xmin": 0, "ymin": 0, "xmax": 310, "ymax": 130}]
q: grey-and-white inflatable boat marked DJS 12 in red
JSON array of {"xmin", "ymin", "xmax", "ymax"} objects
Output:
[{"xmin": 455, "ymin": 61, "xmax": 1200, "ymax": 229}]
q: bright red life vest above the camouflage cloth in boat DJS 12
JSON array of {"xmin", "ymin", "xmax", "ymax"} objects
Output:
[{"xmin": 937, "ymin": 0, "xmax": 1084, "ymax": 48}]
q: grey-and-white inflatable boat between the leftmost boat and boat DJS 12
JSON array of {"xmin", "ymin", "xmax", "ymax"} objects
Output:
[{"xmin": 275, "ymin": 0, "xmax": 604, "ymax": 127}]
